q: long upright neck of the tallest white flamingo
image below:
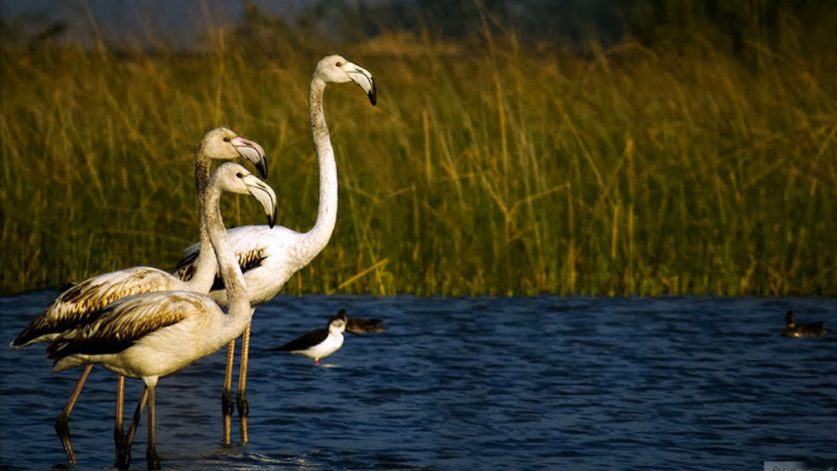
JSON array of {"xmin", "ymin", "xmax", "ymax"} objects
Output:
[{"xmin": 302, "ymin": 77, "xmax": 337, "ymax": 263}]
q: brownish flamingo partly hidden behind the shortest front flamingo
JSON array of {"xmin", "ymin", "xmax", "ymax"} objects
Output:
[{"xmin": 11, "ymin": 128, "xmax": 267, "ymax": 463}]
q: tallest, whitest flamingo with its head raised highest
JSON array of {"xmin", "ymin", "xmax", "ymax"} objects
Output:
[{"xmin": 175, "ymin": 55, "xmax": 377, "ymax": 445}]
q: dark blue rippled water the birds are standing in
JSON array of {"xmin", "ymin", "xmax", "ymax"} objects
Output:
[{"xmin": 0, "ymin": 292, "xmax": 837, "ymax": 470}]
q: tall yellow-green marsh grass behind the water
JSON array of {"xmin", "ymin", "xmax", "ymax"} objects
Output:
[{"xmin": 0, "ymin": 25, "xmax": 837, "ymax": 296}]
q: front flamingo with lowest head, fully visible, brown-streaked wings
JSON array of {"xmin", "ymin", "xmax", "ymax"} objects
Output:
[{"xmin": 47, "ymin": 163, "xmax": 276, "ymax": 469}]
